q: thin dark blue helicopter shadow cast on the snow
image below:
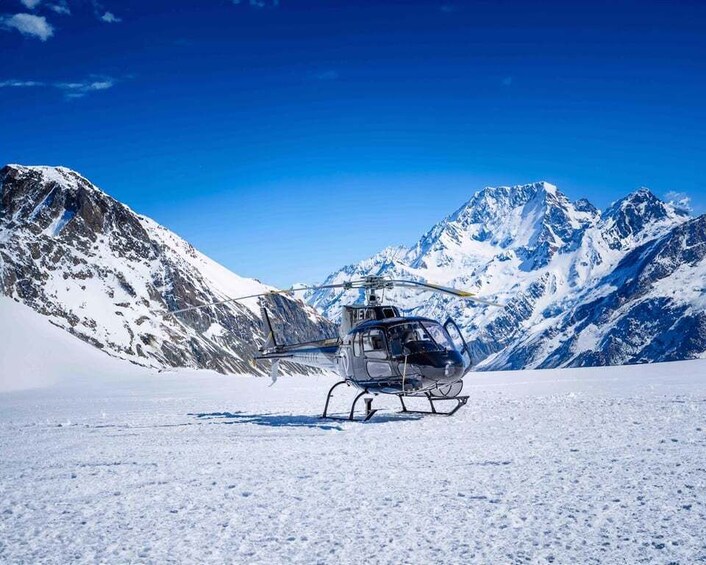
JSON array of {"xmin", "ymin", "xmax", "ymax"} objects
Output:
[{"xmin": 187, "ymin": 412, "xmax": 421, "ymax": 431}]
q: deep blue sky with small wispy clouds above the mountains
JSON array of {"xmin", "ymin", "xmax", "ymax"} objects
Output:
[{"xmin": 0, "ymin": 0, "xmax": 706, "ymax": 286}]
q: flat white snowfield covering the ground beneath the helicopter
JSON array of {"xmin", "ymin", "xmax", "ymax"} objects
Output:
[{"xmin": 0, "ymin": 298, "xmax": 706, "ymax": 564}]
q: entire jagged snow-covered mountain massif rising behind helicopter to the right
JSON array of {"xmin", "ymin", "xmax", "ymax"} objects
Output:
[{"xmin": 307, "ymin": 178, "xmax": 706, "ymax": 369}]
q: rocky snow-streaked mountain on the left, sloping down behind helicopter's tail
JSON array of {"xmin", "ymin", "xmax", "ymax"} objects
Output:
[{"xmin": 0, "ymin": 165, "xmax": 334, "ymax": 373}]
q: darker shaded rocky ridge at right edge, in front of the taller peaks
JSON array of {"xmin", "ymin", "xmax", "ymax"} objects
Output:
[{"xmin": 492, "ymin": 216, "xmax": 706, "ymax": 369}]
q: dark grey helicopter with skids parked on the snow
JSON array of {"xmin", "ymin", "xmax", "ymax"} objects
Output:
[{"xmin": 171, "ymin": 276, "xmax": 500, "ymax": 421}]
